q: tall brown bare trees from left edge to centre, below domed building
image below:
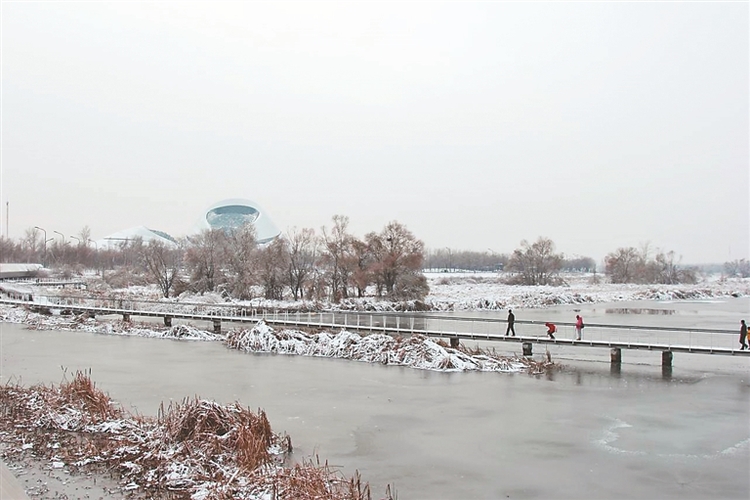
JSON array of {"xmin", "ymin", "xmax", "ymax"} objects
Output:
[{"xmin": 0, "ymin": 215, "xmax": 429, "ymax": 302}]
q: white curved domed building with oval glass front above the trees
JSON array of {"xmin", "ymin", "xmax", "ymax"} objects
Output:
[{"xmin": 195, "ymin": 198, "xmax": 281, "ymax": 243}]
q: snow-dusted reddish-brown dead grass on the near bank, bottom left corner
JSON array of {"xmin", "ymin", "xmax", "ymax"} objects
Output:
[{"xmin": 0, "ymin": 372, "xmax": 393, "ymax": 500}]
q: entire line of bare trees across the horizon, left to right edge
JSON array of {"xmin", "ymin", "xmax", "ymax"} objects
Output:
[{"xmin": 0, "ymin": 224, "xmax": 750, "ymax": 292}]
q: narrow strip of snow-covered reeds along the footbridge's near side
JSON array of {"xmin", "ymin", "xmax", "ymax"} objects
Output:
[{"xmin": 0, "ymin": 306, "xmax": 554, "ymax": 374}]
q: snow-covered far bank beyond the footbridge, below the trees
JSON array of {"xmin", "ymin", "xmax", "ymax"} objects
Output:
[{"xmin": 14, "ymin": 272, "xmax": 750, "ymax": 311}]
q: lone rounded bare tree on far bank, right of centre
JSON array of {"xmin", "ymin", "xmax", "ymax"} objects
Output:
[{"xmin": 508, "ymin": 236, "xmax": 563, "ymax": 285}]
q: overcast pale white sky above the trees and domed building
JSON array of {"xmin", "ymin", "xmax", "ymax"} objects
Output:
[{"xmin": 0, "ymin": 2, "xmax": 750, "ymax": 263}]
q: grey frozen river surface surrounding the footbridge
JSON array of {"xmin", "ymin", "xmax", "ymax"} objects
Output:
[{"xmin": 0, "ymin": 299, "xmax": 750, "ymax": 500}]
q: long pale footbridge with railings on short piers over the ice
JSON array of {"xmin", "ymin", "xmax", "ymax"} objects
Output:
[{"xmin": 0, "ymin": 296, "xmax": 750, "ymax": 366}]
